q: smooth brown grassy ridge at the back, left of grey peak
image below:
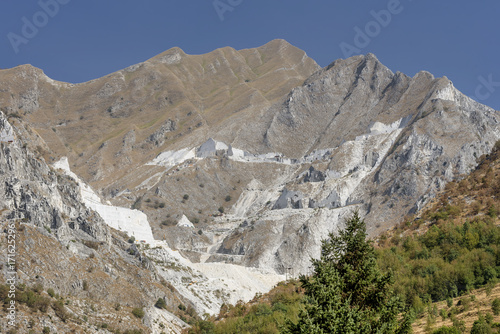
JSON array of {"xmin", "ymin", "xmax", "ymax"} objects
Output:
[{"xmin": 0, "ymin": 40, "xmax": 319, "ymax": 187}]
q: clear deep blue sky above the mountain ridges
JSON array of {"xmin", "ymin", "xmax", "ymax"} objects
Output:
[{"xmin": 0, "ymin": 0, "xmax": 500, "ymax": 110}]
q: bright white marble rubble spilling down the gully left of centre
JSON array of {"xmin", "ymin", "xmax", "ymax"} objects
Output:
[{"xmin": 54, "ymin": 157, "xmax": 285, "ymax": 318}]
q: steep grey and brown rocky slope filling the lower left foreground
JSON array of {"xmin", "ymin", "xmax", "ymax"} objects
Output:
[{"xmin": 0, "ymin": 112, "xmax": 191, "ymax": 333}]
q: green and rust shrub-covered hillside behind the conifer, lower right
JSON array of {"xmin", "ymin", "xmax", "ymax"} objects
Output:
[{"xmin": 189, "ymin": 142, "xmax": 500, "ymax": 334}]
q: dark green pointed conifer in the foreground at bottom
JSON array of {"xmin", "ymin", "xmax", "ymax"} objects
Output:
[{"xmin": 282, "ymin": 212, "xmax": 412, "ymax": 334}]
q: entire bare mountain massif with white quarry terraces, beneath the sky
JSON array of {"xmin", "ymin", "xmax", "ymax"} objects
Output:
[{"xmin": 0, "ymin": 40, "xmax": 500, "ymax": 328}]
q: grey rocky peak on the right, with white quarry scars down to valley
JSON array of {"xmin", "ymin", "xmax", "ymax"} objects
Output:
[{"xmin": 212, "ymin": 54, "xmax": 500, "ymax": 272}]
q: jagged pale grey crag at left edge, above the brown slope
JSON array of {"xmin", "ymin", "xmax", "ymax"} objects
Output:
[{"xmin": 0, "ymin": 112, "xmax": 110, "ymax": 243}]
